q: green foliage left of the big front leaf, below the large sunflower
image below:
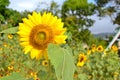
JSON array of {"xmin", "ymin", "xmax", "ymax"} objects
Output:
[{"xmin": 0, "ymin": 33, "xmax": 56, "ymax": 80}]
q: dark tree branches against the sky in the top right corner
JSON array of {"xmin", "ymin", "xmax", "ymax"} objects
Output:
[{"xmin": 95, "ymin": 0, "xmax": 120, "ymax": 25}]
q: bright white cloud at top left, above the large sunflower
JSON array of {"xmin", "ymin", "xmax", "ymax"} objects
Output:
[{"xmin": 8, "ymin": 0, "xmax": 64, "ymax": 12}]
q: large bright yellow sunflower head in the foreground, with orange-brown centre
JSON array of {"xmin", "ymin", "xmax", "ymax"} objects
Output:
[{"xmin": 17, "ymin": 12, "xmax": 67, "ymax": 60}]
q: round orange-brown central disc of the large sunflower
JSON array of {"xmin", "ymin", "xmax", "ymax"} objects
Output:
[{"xmin": 29, "ymin": 24, "xmax": 53, "ymax": 50}]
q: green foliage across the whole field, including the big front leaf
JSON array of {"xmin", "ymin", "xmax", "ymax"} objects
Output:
[{"xmin": 0, "ymin": 28, "xmax": 120, "ymax": 80}]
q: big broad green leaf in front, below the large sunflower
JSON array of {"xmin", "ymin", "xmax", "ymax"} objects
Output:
[{"xmin": 48, "ymin": 44, "xmax": 75, "ymax": 80}]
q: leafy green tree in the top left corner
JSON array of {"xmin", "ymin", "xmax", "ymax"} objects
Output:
[{"xmin": 0, "ymin": 0, "xmax": 21, "ymax": 27}]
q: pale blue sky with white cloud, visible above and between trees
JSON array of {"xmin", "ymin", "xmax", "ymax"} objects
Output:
[{"xmin": 8, "ymin": 0, "xmax": 117, "ymax": 34}]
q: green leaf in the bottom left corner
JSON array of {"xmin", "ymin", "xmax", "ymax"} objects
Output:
[{"xmin": 0, "ymin": 72, "xmax": 25, "ymax": 80}]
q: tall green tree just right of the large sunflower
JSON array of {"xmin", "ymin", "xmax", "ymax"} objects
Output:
[{"xmin": 61, "ymin": 0, "xmax": 95, "ymax": 45}]
